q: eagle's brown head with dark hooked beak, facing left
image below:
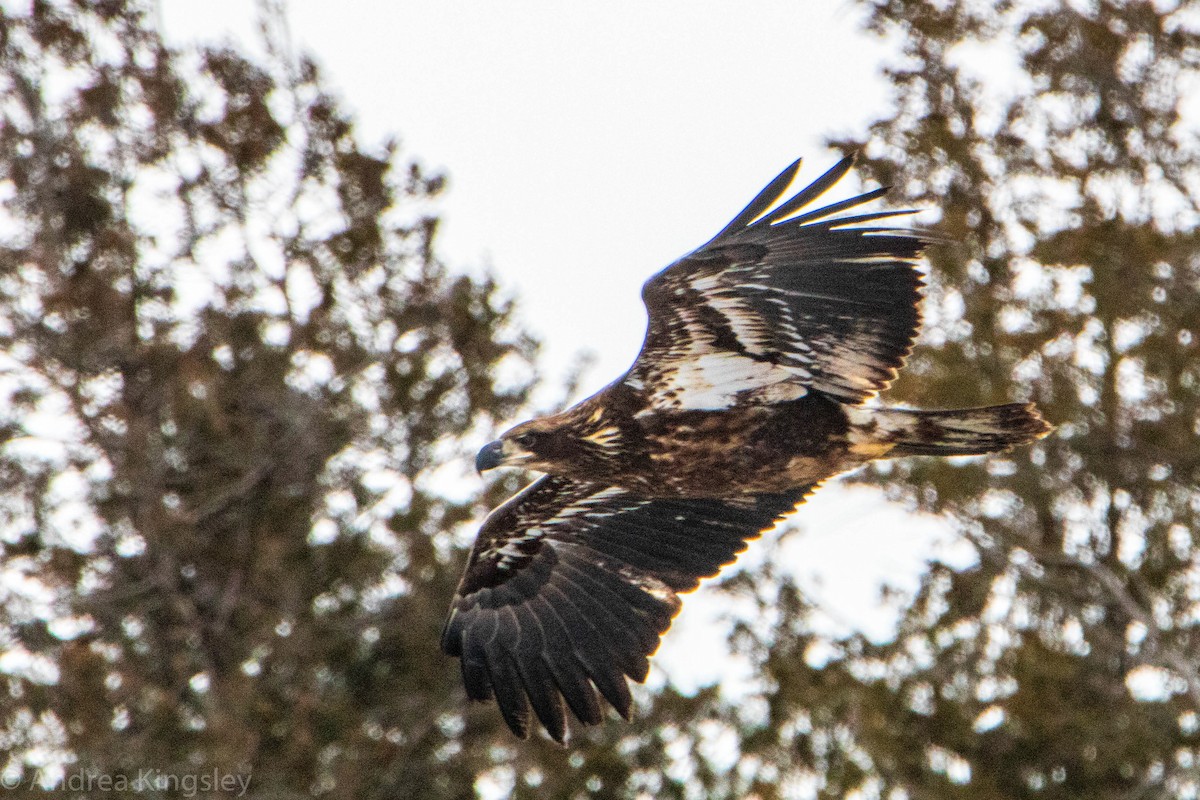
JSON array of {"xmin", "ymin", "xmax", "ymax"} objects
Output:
[{"xmin": 475, "ymin": 409, "xmax": 620, "ymax": 475}]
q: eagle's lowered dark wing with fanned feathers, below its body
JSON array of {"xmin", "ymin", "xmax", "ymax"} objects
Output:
[{"xmin": 442, "ymin": 475, "xmax": 814, "ymax": 741}]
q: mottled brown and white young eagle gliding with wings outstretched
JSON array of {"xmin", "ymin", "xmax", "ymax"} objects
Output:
[{"xmin": 442, "ymin": 157, "xmax": 1050, "ymax": 742}]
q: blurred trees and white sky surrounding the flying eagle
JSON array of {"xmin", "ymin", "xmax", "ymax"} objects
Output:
[{"xmin": 0, "ymin": 0, "xmax": 1200, "ymax": 800}]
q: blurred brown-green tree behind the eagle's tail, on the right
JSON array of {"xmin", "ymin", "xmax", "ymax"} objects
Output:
[{"xmin": 672, "ymin": 0, "xmax": 1200, "ymax": 800}]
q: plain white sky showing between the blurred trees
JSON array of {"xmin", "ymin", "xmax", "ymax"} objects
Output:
[{"xmin": 154, "ymin": 0, "xmax": 970, "ymax": 687}]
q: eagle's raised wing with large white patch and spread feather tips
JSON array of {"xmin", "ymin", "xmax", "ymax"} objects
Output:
[{"xmin": 623, "ymin": 157, "xmax": 928, "ymax": 409}]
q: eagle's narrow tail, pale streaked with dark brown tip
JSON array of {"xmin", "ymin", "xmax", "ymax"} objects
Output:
[{"xmin": 874, "ymin": 403, "xmax": 1052, "ymax": 457}]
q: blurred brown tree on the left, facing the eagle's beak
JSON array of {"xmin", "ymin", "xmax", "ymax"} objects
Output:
[{"xmin": 0, "ymin": 0, "xmax": 544, "ymax": 798}]
